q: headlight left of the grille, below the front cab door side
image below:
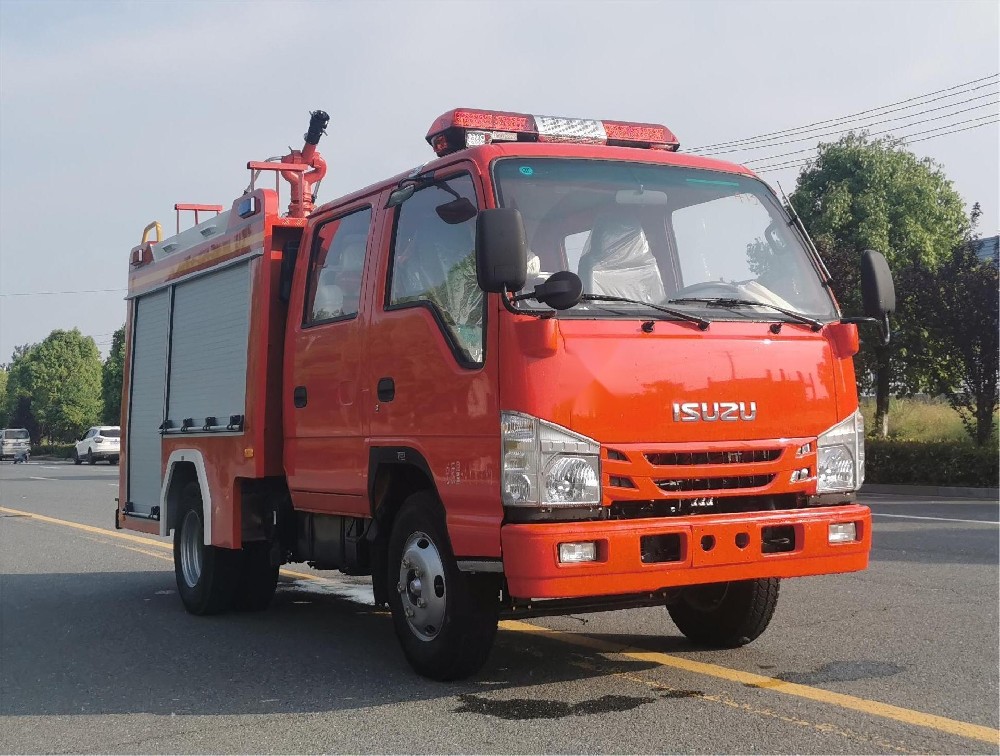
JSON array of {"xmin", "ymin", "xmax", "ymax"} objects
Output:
[{"xmin": 500, "ymin": 412, "xmax": 601, "ymax": 507}]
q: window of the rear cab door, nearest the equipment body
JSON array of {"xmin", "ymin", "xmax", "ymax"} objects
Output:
[{"xmin": 304, "ymin": 207, "xmax": 372, "ymax": 326}]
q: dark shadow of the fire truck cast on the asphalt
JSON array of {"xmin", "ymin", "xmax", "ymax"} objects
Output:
[{"xmin": 0, "ymin": 571, "xmax": 672, "ymax": 719}]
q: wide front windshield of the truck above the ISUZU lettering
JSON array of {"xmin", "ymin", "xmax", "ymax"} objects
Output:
[{"xmin": 493, "ymin": 158, "xmax": 838, "ymax": 320}]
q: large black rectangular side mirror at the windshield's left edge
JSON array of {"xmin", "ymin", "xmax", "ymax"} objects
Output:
[{"xmin": 476, "ymin": 208, "xmax": 528, "ymax": 292}]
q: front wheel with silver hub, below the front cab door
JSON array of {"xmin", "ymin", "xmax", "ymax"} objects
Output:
[{"xmin": 387, "ymin": 492, "xmax": 500, "ymax": 680}]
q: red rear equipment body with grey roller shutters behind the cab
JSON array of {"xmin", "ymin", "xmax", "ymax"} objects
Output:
[{"xmin": 117, "ymin": 190, "xmax": 304, "ymax": 548}]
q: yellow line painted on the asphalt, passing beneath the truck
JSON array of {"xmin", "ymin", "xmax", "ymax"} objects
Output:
[{"xmin": 0, "ymin": 507, "xmax": 1000, "ymax": 745}]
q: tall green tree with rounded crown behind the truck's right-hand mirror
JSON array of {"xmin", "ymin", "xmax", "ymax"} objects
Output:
[{"xmin": 790, "ymin": 133, "xmax": 969, "ymax": 436}]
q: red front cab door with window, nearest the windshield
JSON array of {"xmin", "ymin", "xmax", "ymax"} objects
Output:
[{"xmin": 367, "ymin": 162, "xmax": 502, "ymax": 555}]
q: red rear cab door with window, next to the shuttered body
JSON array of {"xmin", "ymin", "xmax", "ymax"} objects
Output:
[{"xmin": 283, "ymin": 200, "xmax": 374, "ymax": 514}]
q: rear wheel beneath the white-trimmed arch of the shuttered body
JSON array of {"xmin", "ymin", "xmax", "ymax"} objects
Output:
[{"xmin": 174, "ymin": 483, "xmax": 240, "ymax": 615}]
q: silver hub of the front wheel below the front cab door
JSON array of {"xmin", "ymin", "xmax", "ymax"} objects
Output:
[{"xmin": 396, "ymin": 532, "xmax": 448, "ymax": 641}]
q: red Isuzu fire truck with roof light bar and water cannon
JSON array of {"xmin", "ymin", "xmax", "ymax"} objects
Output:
[{"xmin": 116, "ymin": 108, "xmax": 895, "ymax": 679}]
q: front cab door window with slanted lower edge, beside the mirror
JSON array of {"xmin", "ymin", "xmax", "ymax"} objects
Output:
[{"xmin": 388, "ymin": 173, "xmax": 483, "ymax": 365}]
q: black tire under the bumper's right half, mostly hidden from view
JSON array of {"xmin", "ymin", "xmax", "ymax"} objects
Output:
[{"xmin": 667, "ymin": 578, "xmax": 781, "ymax": 648}]
